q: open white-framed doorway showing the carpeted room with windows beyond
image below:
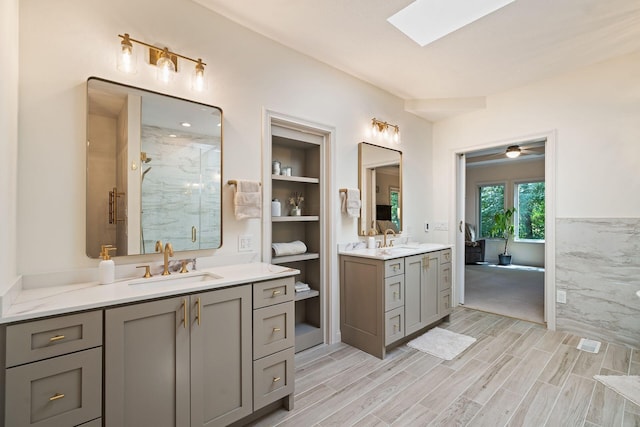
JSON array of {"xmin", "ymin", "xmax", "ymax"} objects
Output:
[{"xmin": 454, "ymin": 133, "xmax": 555, "ymax": 329}]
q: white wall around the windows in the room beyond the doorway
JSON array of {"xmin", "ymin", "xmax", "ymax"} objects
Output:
[{"xmin": 465, "ymin": 159, "xmax": 544, "ymax": 267}]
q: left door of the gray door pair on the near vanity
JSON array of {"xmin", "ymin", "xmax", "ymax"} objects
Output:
[{"xmin": 104, "ymin": 297, "xmax": 190, "ymax": 427}]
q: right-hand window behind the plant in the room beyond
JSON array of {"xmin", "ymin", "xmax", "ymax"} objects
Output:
[{"xmin": 514, "ymin": 181, "xmax": 544, "ymax": 240}]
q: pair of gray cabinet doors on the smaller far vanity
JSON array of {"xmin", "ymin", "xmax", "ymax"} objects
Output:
[{"xmin": 404, "ymin": 252, "xmax": 440, "ymax": 335}]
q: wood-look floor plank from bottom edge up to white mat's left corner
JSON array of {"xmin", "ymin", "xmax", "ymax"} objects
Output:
[{"xmin": 547, "ymin": 375, "xmax": 595, "ymax": 426}]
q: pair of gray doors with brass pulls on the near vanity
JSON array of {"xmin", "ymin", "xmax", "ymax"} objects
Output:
[{"xmin": 105, "ymin": 285, "xmax": 252, "ymax": 427}]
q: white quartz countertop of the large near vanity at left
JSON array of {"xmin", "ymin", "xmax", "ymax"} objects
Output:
[{"xmin": 0, "ymin": 263, "xmax": 299, "ymax": 323}]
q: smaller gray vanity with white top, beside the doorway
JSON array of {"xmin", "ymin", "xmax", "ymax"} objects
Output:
[{"xmin": 340, "ymin": 244, "xmax": 451, "ymax": 359}]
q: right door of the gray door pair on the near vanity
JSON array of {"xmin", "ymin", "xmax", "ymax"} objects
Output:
[{"xmin": 191, "ymin": 285, "xmax": 252, "ymax": 426}]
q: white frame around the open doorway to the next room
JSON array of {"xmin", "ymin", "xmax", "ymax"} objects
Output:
[{"xmin": 452, "ymin": 130, "xmax": 557, "ymax": 330}]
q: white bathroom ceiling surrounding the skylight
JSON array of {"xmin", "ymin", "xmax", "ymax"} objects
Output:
[{"xmin": 193, "ymin": 0, "xmax": 640, "ymax": 120}]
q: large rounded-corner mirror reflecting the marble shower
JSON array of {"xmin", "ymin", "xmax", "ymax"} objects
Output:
[{"xmin": 86, "ymin": 77, "xmax": 222, "ymax": 258}]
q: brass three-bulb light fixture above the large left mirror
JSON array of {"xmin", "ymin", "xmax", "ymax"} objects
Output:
[{"xmin": 118, "ymin": 33, "xmax": 207, "ymax": 92}]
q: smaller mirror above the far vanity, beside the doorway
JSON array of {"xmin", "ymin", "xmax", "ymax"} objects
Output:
[{"xmin": 358, "ymin": 142, "xmax": 402, "ymax": 236}]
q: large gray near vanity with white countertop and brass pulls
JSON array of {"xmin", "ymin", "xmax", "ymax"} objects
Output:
[{"xmin": 0, "ymin": 263, "xmax": 298, "ymax": 426}]
